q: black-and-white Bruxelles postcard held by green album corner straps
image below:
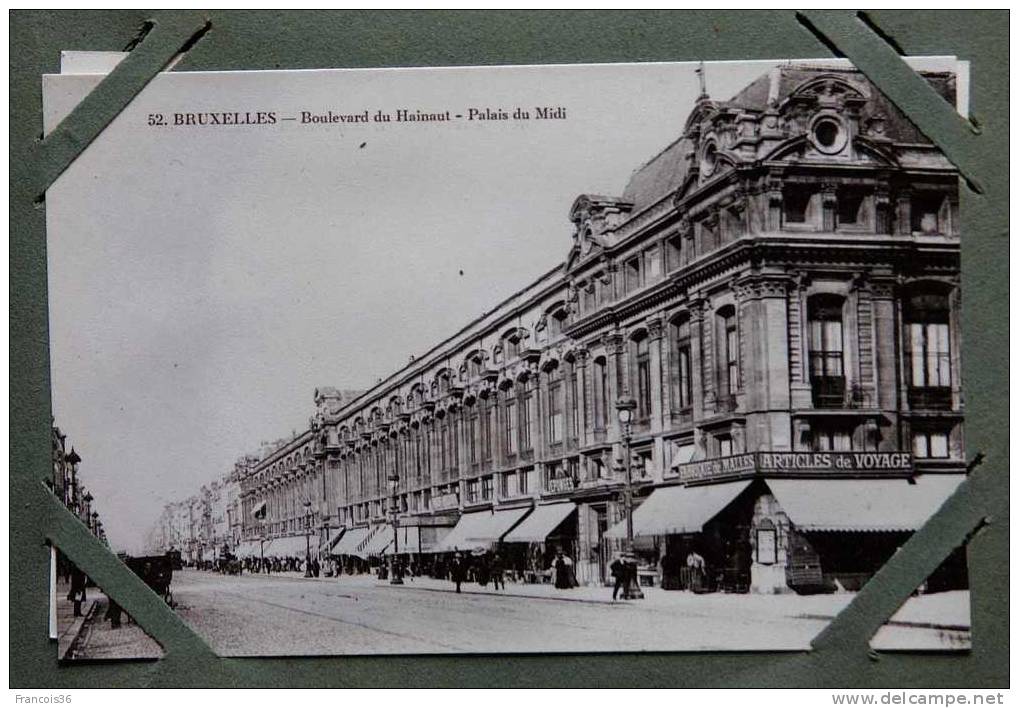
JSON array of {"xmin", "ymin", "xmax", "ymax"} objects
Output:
[{"xmin": 43, "ymin": 52, "xmax": 973, "ymax": 660}]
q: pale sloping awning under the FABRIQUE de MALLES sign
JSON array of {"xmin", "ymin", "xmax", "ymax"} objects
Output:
[{"xmin": 605, "ymin": 480, "xmax": 751, "ymax": 539}]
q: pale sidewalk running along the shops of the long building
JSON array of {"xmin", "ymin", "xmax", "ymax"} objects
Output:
[{"xmin": 229, "ymin": 573, "xmax": 970, "ymax": 631}]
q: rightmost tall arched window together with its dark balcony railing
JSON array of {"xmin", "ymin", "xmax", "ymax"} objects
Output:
[{"xmin": 904, "ymin": 289, "xmax": 952, "ymax": 409}]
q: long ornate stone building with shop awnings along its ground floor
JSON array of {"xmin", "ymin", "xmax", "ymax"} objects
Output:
[{"xmin": 156, "ymin": 64, "xmax": 965, "ymax": 593}]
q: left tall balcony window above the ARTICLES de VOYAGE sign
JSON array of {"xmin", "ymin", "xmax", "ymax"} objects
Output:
[{"xmin": 808, "ymin": 294, "xmax": 846, "ymax": 409}]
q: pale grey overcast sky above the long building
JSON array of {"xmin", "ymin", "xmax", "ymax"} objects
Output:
[{"xmin": 47, "ymin": 56, "xmax": 953, "ymax": 552}]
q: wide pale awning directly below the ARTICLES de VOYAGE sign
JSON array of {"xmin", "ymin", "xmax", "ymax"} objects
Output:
[{"xmin": 766, "ymin": 475, "xmax": 965, "ymax": 531}]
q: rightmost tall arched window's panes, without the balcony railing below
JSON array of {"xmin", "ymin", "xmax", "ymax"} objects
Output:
[{"xmin": 905, "ymin": 292, "xmax": 952, "ymax": 388}]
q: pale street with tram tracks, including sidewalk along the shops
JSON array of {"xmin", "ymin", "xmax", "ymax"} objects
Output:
[{"xmin": 174, "ymin": 570, "xmax": 969, "ymax": 656}]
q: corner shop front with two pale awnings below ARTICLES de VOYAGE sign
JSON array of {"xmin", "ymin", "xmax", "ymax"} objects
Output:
[{"xmin": 605, "ymin": 475, "xmax": 964, "ymax": 594}]
